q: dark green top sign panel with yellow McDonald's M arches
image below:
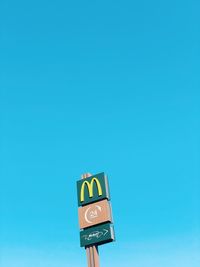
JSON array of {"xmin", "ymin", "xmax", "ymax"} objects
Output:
[{"xmin": 77, "ymin": 172, "xmax": 109, "ymax": 206}]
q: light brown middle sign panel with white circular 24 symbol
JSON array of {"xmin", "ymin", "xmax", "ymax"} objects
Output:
[{"xmin": 78, "ymin": 199, "xmax": 112, "ymax": 229}]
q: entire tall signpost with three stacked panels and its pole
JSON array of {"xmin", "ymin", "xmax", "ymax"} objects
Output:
[{"xmin": 77, "ymin": 173, "xmax": 115, "ymax": 267}]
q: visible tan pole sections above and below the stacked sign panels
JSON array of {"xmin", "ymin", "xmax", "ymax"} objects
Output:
[{"xmin": 81, "ymin": 173, "xmax": 100, "ymax": 267}]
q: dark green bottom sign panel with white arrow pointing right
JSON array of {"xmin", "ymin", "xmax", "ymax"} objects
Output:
[{"xmin": 80, "ymin": 223, "xmax": 115, "ymax": 247}]
